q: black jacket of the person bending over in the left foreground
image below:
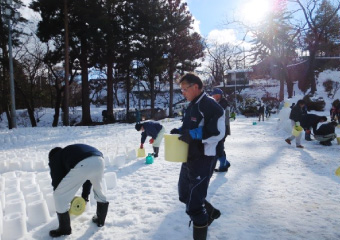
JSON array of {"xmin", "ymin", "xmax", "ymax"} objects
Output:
[{"xmin": 48, "ymin": 144, "xmax": 103, "ymax": 190}]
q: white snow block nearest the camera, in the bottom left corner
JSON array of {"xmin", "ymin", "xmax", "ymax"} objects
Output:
[{"xmin": 2, "ymin": 212, "xmax": 27, "ymax": 240}]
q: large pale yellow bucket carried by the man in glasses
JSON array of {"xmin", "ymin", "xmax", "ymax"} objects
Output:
[{"xmin": 164, "ymin": 134, "xmax": 189, "ymax": 162}]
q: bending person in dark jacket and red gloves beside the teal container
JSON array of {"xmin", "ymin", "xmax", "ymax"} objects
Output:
[{"xmin": 135, "ymin": 121, "xmax": 165, "ymax": 158}]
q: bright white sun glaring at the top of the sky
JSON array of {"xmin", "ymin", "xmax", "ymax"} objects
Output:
[{"xmin": 241, "ymin": 0, "xmax": 272, "ymax": 23}]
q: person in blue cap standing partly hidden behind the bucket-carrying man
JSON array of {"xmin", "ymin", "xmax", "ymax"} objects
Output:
[{"xmin": 211, "ymin": 88, "xmax": 230, "ymax": 172}]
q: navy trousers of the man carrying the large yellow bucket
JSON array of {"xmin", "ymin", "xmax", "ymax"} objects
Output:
[{"xmin": 178, "ymin": 156, "xmax": 217, "ymax": 226}]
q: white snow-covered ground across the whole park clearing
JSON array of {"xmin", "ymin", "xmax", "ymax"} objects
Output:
[{"xmin": 0, "ymin": 72, "xmax": 340, "ymax": 240}]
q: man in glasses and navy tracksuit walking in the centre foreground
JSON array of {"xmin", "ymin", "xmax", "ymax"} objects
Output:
[{"xmin": 170, "ymin": 73, "xmax": 225, "ymax": 240}]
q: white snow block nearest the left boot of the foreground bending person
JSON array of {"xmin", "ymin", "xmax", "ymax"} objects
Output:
[{"xmin": 27, "ymin": 200, "xmax": 50, "ymax": 227}]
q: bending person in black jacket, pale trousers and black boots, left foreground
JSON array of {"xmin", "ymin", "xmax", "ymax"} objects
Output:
[{"xmin": 48, "ymin": 144, "xmax": 109, "ymax": 237}]
